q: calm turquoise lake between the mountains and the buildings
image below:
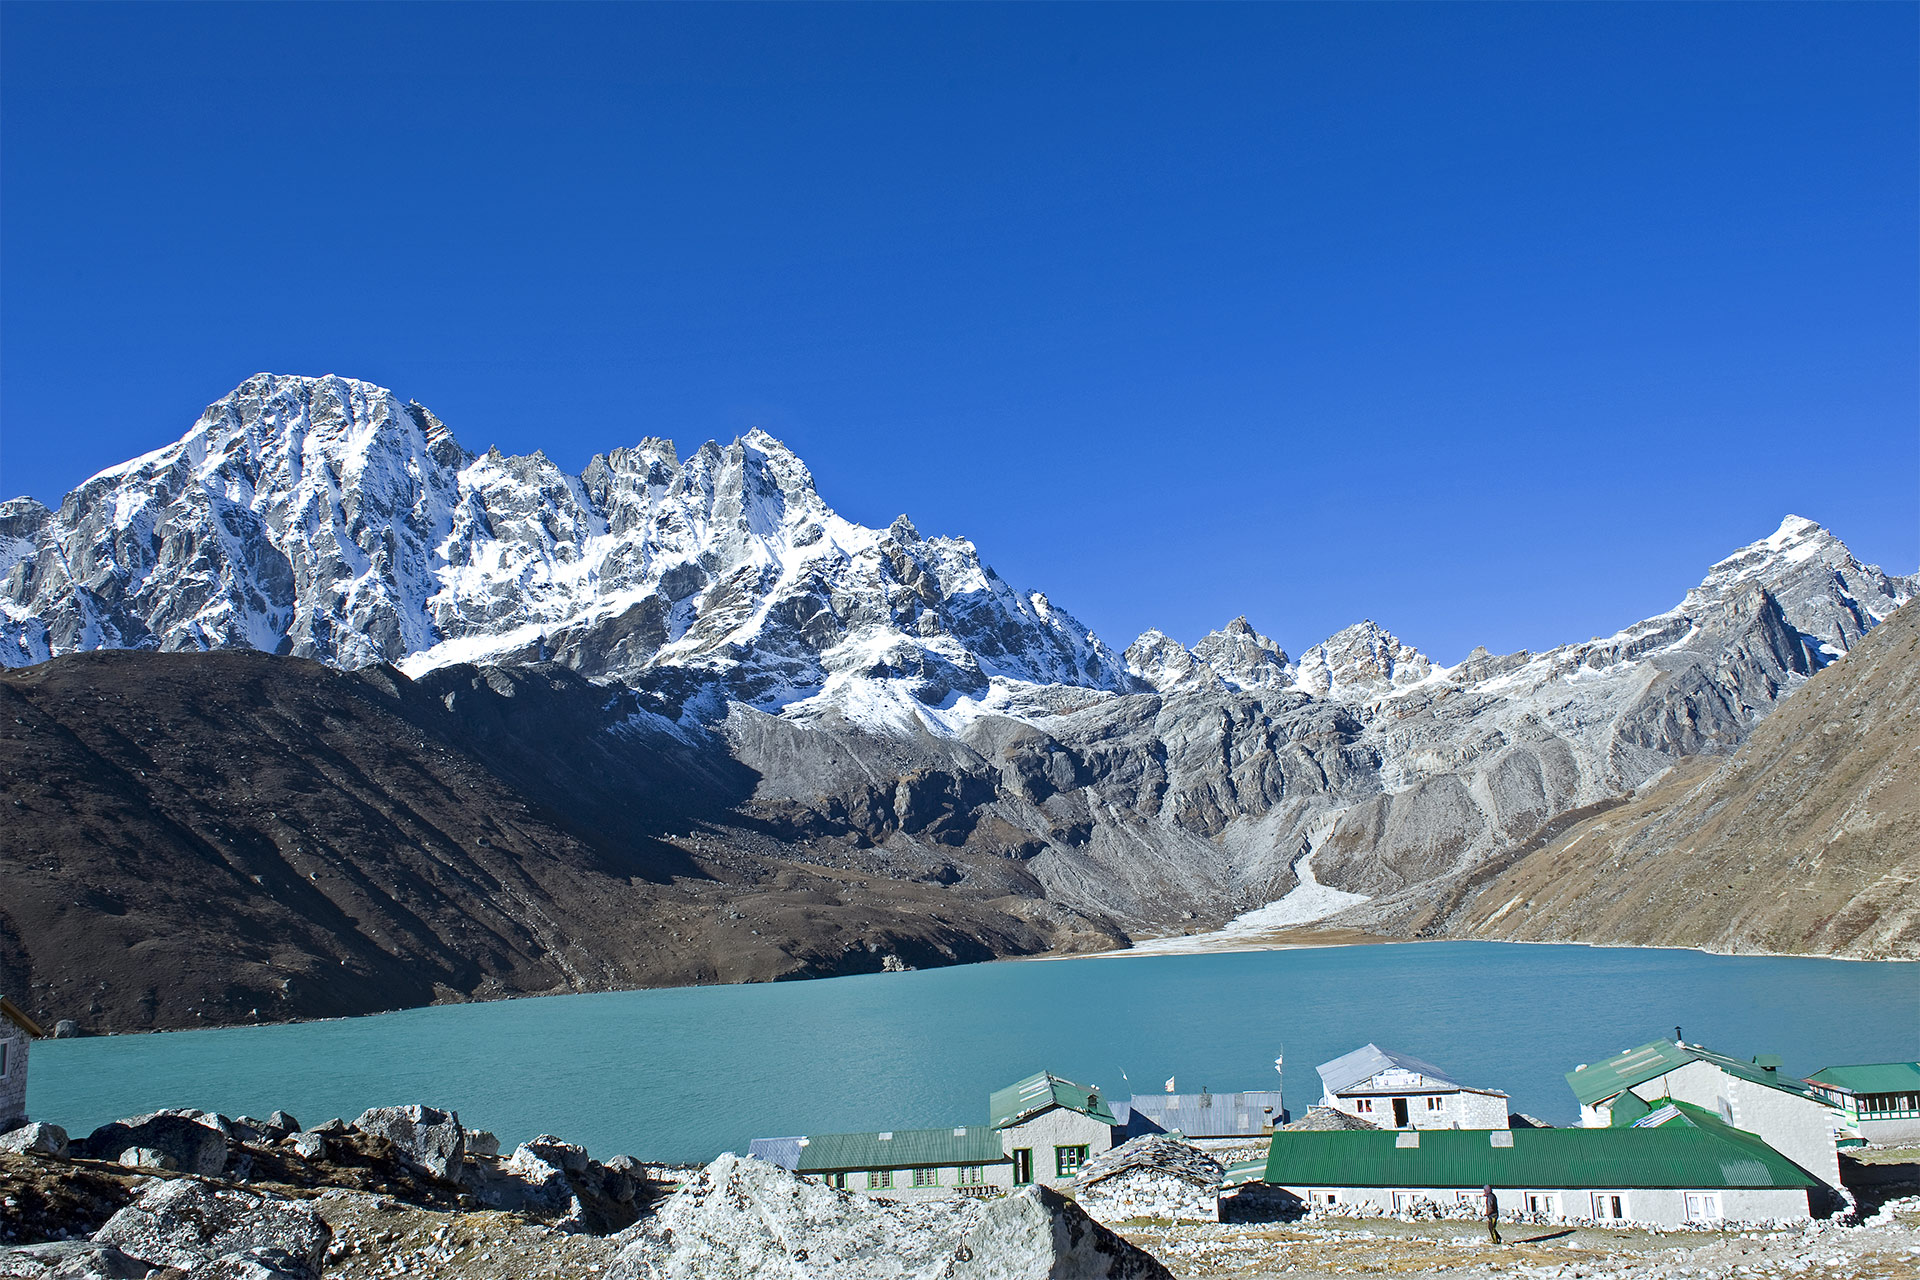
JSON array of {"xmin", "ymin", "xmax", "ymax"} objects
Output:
[{"xmin": 27, "ymin": 942, "xmax": 1920, "ymax": 1161}]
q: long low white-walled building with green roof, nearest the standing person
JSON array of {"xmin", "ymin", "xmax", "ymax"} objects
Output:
[{"xmin": 1242, "ymin": 1105, "xmax": 1820, "ymax": 1226}]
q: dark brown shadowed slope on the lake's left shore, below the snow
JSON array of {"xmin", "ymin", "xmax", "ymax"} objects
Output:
[{"xmin": 0, "ymin": 651, "xmax": 1116, "ymax": 1031}]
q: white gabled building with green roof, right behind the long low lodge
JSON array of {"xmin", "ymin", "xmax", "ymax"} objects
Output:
[{"xmin": 1567, "ymin": 1040, "xmax": 1859, "ymax": 1207}]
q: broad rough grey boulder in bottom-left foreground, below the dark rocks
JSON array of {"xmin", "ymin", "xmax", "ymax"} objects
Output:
[{"xmin": 94, "ymin": 1178, "xmax": 334, "ymax": 1280}]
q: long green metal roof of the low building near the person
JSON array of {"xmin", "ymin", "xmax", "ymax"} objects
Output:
[{"xmin": 1265, "ymin": 1125, "xmax": 1814, "ymax": 1190}]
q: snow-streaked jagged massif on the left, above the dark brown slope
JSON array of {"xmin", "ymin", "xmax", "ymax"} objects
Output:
[{"xmin": 0, "ymin": 374, "xmax": 1135, "ymax": 725}]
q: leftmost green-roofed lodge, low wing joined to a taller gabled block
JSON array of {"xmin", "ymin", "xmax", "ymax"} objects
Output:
[{"xmin": 747, "ymin": 1071, "xmax": 1117, "ymax": 1199}]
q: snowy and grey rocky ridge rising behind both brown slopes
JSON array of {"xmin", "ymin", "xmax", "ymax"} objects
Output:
[{"xmin": 0, "ymin": 374, "xmax": 1920, "ymax": 997}]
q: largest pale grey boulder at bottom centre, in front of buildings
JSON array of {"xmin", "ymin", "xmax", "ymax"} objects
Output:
[{"xmin": 607, "ymin": 1155, "xmax": 1167, "ymax": 1280}]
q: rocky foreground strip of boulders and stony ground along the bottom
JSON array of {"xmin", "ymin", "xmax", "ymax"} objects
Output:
[{"xmin": 0, "ymin": 1107, "xmax": 1920, "ymax": 1280}]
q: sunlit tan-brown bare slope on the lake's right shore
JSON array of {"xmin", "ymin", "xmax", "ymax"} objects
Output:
[{"xmin": 1428, "ymin": 604, "xmax": 1920, "ymax": 958}]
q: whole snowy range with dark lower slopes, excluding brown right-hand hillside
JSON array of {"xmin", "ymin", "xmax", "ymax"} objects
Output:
[{"xmin": 0, "ymin": 374, "xmax": 1920, "ymax": 1025}]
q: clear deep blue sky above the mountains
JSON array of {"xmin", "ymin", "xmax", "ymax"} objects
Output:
[{"xmin": 0, "ymin": 4, "xmax": 1920, "ymax": 660}]
